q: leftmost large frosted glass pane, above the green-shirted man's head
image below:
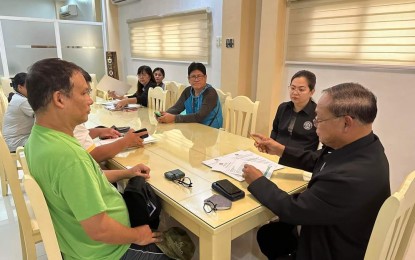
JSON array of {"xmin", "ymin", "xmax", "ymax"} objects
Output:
[{"xmin": 1, "ymin": 20, "xmax": 57, "ymax": 75}]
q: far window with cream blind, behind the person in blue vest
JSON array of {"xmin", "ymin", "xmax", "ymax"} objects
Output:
[{"xmin": 128, "ymin": 10, "xmax": 210, "ymax": 63}]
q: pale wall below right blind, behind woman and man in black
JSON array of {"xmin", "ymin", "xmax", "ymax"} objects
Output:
[{"xmin": 284, "ymin": 65, "xmax": 415, "ymax": 192}]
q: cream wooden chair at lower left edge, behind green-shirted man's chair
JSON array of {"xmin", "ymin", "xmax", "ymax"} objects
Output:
[{"xmin": 0, "ymin": 133, "xmax": 42, "ymax": 260}]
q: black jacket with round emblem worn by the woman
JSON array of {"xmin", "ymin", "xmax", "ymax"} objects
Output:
[{"xmin": 271, "ymin": 100, "xmax": 319, "ymax": 151}]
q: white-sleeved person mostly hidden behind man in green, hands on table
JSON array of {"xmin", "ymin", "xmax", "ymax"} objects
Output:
[{"xmin": 74, "ymin": 69, "xmax": 147, "ymax": 163}]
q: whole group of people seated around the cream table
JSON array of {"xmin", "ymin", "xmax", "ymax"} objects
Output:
[{"xmin": 3, "ymin": 59, "xmax": 390, "ymax": 259}]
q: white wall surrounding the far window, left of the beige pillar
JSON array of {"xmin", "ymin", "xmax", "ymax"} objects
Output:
[{"xmin": 117, "ymin": 0, "xmax": 222, "ymax": 88}]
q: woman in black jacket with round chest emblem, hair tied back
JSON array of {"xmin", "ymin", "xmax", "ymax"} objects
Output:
[{"xmin": 271, "ymin": 70, "xmax": 319, "ymax": 151}]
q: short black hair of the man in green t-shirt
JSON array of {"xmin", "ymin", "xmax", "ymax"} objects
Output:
[{"xmin": 26, "ymin": 58, "xmax": 82, "ymax": 112}]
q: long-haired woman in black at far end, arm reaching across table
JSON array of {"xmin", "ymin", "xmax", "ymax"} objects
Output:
[{"xmin": 108, "ymin": 65, "xmax": 157, "ymax": 109}]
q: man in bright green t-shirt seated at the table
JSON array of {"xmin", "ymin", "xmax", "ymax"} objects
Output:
[{"xmin": 25, "ymin": 58, "xmax": 168, "ymax": 260}]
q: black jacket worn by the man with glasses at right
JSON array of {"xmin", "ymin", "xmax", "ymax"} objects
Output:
[{"xmin": 248, "ymin": 133, "xmax": 390, "ymax": 260}]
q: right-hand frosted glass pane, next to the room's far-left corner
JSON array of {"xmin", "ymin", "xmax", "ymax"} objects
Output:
[{"xmin": 59, "ymin": 23, "xmax": 105, "ymax": 81}]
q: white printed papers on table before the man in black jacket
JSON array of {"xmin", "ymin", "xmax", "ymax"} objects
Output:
[{"xmin": 203, "ymin": 151, "xmax": 284, "ymax": 181}]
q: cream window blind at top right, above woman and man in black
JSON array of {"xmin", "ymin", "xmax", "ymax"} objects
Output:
[{"xmin": 286, "ymin": 0, "xmax": 415, "ymax": 66}]
